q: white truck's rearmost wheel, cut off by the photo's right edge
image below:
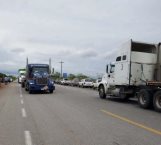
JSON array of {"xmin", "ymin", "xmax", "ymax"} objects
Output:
[{"xmin": 153, "ymin": 91, "xmax": 161, "ymax": 112}]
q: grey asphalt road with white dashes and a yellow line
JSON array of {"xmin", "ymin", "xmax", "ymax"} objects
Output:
[{"xmin": 0, "ymin": 83, "xmax": 161, "ymax": 145}]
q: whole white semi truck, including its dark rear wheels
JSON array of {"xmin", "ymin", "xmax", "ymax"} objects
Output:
[{"xmin": 98, "ymin": 40, "xmax": 161, "ymax": 112}]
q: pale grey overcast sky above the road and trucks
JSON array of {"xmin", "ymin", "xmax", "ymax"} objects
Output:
[{"xmin": 0, "ymin": 0, "xmax": 161, "ymax": 75}]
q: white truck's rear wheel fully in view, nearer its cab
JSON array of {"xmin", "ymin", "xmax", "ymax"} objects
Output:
[{"xmin": 138, "ymin": 89, "xmax": 152, "ymax": 109}]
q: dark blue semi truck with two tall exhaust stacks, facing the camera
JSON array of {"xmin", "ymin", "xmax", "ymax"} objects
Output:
[{"xmin": 24, "ymin": 60, "xmax": 55, "ymax": 94}]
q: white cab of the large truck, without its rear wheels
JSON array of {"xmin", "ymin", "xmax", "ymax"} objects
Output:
[{"xmin": 98, "ymin": 40, "xmax": 157, "ymax": 100}]
